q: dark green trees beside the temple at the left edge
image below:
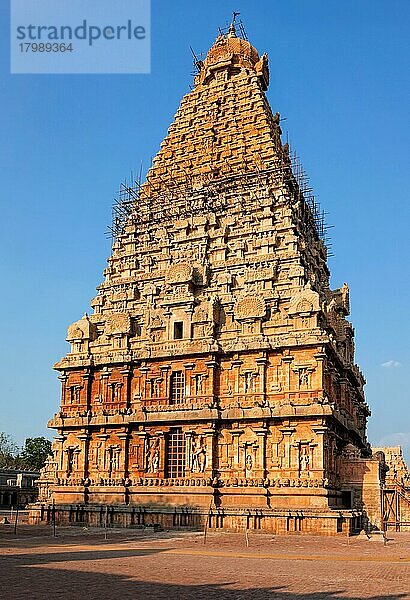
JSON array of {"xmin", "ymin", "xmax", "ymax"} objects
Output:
[{"xmin": 0, "ymin": 431, "xmax": 51, "ymax": 471}]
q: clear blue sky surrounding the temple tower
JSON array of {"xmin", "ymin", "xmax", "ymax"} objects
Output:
[{"xmin": 0, "ymin": 0, "xmax": 410, "ymax": 456}]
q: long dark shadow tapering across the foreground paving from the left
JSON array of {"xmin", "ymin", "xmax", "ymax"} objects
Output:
[{"xmin": 0, "ymin": 548, "xmax": 408, "ymax": 600}]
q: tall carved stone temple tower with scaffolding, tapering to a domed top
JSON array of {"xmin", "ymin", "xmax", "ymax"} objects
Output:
[{"xmin": 31, "ymin": 24, "xmax": 410, "ymax": 534}]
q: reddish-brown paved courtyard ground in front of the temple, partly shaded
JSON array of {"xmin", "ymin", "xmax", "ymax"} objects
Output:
[{"xmin": 0, "ymin": 524, "xmax": 410, "ymax": 600}]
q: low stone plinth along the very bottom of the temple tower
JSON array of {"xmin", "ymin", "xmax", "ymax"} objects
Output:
[{"xmin": 29, "ymin": 503, "xmax": 364, "ymax": 535}]
